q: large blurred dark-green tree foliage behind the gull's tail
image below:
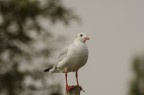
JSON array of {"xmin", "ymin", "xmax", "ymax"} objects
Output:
[{"xmin": 0, "ymin": 0, "xmax": 77, "ymax": 95}]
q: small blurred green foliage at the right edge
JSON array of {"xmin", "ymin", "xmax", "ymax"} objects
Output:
[{"xmin": 130, "ymin": 54, "xmax": 144, "ymax": 95}]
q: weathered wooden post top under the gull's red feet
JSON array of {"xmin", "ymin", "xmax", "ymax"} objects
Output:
[{"xmin": 66, "ymin": 86, "xmax": 84, "ymax": 95}]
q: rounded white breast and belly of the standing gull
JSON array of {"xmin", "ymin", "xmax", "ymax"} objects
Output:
[{"xmin": 67, "ymin": 42, "xmax": 88, "ymax": 71}]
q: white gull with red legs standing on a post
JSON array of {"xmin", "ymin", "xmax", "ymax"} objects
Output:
[{"xmin": 44, "ymin": 33, "xmax": 89, "ymax": 91}]
